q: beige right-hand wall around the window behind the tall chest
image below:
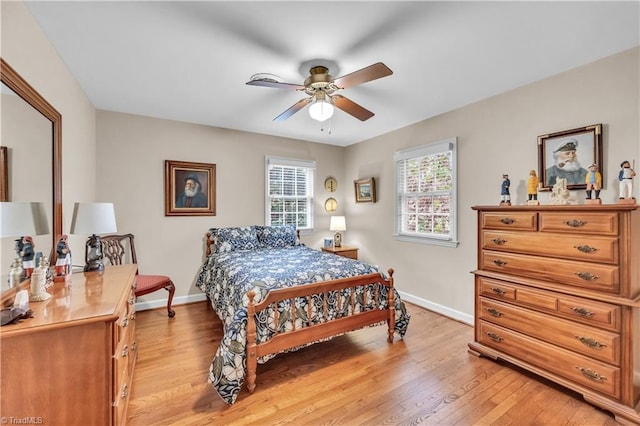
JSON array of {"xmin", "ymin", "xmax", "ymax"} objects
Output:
[{"xmin": 345, "ymin": 48, "xmax": 640, "ymax": 321}]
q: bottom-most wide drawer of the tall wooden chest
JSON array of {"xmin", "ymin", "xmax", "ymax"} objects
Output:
[{"xmin": 476, "ymin": 320, "xmax": 621, "ymax": 400}]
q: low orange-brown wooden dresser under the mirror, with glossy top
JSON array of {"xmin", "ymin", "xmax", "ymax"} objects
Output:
[{"xmin": 0, "ymin": 265, "xmax": 137, "ymax": 426}]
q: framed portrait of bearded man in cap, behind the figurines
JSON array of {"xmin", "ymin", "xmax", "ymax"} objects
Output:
[{"xmin": 538, "ymin": 124, "xmax": 604, "ymax": 191}]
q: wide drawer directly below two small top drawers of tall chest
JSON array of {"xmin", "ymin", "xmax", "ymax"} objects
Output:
[{"xmin": 482, "ymin": 231, "xmax": 618, "ymax": 264}]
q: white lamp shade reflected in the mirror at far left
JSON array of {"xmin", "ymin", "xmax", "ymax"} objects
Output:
[{"xmin": 0, "ymin": 202, "xmax": 49, "ymax": 237}]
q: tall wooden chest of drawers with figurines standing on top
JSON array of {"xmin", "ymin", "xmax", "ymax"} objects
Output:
[{"xmin": 469, "ymin": 205, "xmax": 640, "ymax": 424}]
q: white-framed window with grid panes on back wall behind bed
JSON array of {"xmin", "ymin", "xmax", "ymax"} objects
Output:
[{"xmin": 265, "ymin": 157, "xmax": 316, "ymax": 230}]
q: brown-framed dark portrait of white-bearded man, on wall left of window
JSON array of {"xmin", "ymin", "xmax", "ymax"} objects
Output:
[{"xmin": 164, "ymin": 160, "xmax": 216, "ymax": 216}]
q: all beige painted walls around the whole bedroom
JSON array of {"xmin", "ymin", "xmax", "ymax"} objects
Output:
[{"xmin": 6, "ymin": 1, "xmax": 640, "ymax": 321}]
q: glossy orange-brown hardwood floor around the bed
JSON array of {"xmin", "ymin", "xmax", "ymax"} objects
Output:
[{"xmin": 128, "ymin": 302, "xmax": 617, "ymax": 426}]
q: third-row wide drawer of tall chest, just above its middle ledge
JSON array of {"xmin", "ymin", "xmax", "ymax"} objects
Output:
[{"xmin": 480, "ymin": 250, "xmax": 620, "ymax": 293}]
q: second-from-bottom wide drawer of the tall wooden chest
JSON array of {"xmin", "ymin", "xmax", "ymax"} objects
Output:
[{"xmin": 477, "ymin": 297, "xmax": 620, "ymax": 366}]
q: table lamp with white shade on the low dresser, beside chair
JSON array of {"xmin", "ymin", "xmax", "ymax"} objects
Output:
[{"xmin": 71, "ymin": 203, "xmax": 117, "ymax": 272}]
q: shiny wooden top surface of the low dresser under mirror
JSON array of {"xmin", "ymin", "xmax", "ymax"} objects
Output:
[{"xmin": 0, "ymin": 265, "xmax": 137, "ymax": 337}]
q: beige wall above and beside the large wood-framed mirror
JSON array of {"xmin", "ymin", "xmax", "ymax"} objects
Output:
[{"xmin": 0, "ymin": 1, "xmax": 96, "ymax": 264}]
